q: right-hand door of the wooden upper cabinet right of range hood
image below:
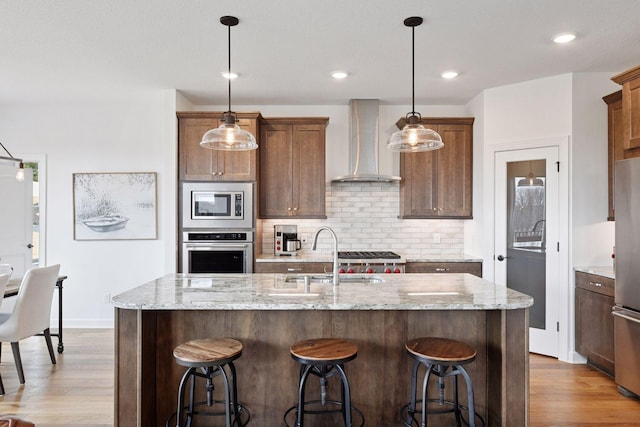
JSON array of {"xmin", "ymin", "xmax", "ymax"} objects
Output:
[{"xmin": 435, "ymin": 125, "xmax": 473, "ymax": 218}]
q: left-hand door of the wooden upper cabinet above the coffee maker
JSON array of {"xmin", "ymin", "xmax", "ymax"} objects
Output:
[{"xmin": 259, "ymin": 125, "xmax": 293, "ymax": 218}]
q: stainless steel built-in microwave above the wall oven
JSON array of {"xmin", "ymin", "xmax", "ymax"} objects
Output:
[{"xmin": 181, "ymin": 182, "xmax": 254, "ymax": 229}]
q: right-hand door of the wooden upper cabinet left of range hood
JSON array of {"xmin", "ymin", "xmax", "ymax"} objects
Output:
[{"xmin": 291, "ymin": 125, "xmax": 325, "ymax": 218}]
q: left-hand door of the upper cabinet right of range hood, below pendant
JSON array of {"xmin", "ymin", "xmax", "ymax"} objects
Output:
[{"xmin": 400, "ymin": 151, "xmax": 438, "ymax": 218}]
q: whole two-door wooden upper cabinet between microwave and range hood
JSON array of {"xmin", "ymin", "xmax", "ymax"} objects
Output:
[{"xmin": 259, "ymin": 118, "xmax": 329, "ymax": 218}]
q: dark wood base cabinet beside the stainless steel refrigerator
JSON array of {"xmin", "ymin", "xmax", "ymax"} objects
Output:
[{"xmin": 575, "ymin": 272, "xmax": 615, "ymax": 376}]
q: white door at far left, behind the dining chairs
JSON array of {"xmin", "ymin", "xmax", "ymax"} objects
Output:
[{"xmin": 0, "ymin": 163, "xmax": 33, "ymax": 277}]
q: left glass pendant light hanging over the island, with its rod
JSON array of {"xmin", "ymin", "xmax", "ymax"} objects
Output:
[{"xmin": 200, "ymin": 16, "xmax": 258, "ymax": 151}]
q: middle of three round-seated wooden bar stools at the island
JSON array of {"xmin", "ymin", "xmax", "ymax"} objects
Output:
[{"xmin": 284, "ymin": 338, "xmax": 364, "ymax": 427}]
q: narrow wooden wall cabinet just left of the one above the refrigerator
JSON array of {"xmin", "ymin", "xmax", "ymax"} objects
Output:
[{"xmin": 602, "ymin": 90, "xmax": 624, "ymax": 221}]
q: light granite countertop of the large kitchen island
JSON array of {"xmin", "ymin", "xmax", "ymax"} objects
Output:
[{"xmin": 112, "ymin": 274, "xmax": 533, "ymax": 310}]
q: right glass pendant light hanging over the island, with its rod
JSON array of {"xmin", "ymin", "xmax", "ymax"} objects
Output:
[{"xmin": 387, "ymin": 16, "xmax": 444, "ymax": 153}]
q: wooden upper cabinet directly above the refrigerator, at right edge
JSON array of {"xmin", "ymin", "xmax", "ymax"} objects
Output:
[{"xmin": 611, "ymin": 65, "xmax": 640, "ymax": 159}]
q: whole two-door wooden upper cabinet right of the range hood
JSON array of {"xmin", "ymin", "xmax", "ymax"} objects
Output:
[{"xmin": 396, "ymin": 117, "xmax": 474, "ymax": 219}]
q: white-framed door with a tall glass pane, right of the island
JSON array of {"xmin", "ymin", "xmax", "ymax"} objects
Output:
[{"xmin": 494, "ymin": 147, "xmax": 562, "ymax": 357}]
